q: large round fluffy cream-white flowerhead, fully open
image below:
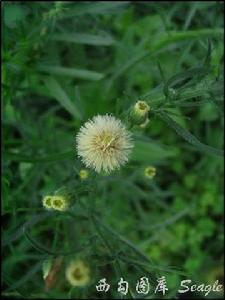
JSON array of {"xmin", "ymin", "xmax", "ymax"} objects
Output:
[{"xmin": 76, "ymin": 115, "xmax": 133, "ymax": 173}]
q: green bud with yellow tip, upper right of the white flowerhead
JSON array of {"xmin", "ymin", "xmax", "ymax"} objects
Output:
[{"xmin": 130, "ymin": 100, "xmax": 150, "ymax": 125}]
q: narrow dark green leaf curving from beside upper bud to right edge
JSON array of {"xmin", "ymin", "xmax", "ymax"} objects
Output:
[{"xmin": 159, "ymin": 112, "xmax": 224, "ymax": 156}]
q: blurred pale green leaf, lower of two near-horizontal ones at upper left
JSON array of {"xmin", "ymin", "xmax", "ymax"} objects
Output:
[{"xmin": 37, "ymin": 65, "xmax": 104, "ymax": 81}]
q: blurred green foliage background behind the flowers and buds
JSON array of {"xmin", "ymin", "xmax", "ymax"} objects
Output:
[{"xmin": 1, "ymin": 1, "xmax": 224, "ymax": 299}]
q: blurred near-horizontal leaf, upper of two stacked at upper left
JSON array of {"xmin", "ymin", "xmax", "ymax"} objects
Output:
[{"xmin": 51, "ymin": 33, "xmax": 115, "ymax": 46}]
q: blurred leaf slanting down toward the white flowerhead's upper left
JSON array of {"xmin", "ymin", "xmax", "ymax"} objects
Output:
[{"xmin": 45, "ymin": 77, "xmax": 82, "ymax": 120}]
